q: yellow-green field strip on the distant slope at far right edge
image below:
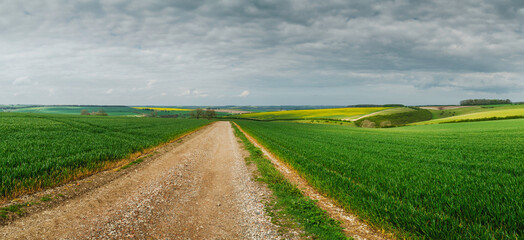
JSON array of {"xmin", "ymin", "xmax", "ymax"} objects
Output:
[{"xmin": 411, "ymin": 108, "xmax": 524, "ymax": 125}]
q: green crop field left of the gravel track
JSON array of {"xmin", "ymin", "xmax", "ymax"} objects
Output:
[{"xmin": 0, "ymin": 113, "xmax": 209, "ymax": 198}]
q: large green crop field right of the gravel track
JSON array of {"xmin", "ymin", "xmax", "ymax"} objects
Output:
[{"xmin": 235, "ymin": 119, "xmax": 524, "ymax": 239}]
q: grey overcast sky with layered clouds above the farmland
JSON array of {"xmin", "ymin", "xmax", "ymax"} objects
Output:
[{"xmin": 0, "ymin": 0, "xmax": 524, "ymax": 105}]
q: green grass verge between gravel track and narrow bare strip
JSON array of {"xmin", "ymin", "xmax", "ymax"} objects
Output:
[{"xmin": 233, "ymin": 125, "xmax": 347, "ymax": 239}]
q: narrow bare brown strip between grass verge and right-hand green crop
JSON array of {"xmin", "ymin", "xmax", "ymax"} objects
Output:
[{"xmin": 233, "ymin": 122, "xmax": 393, "ymax": 239}]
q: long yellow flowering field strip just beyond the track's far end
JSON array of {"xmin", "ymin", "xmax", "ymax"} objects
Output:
[{"xmin": 235, "ymin": 107, "xmax": 389, "ymax": 120}]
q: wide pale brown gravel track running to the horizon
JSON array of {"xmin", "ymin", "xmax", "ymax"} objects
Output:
[{"xmin": 0, "ymin": 122, "xmax": 280, "ymax": 239}]
